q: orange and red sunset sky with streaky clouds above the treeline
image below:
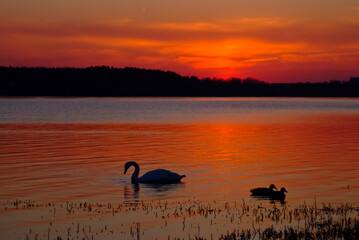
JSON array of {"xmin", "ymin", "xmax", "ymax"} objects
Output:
[{"xmin": 0, "ymin": 0, "xmax": 359, "ymax": 82}]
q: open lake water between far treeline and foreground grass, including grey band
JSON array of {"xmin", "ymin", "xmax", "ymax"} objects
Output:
[{"xmin": 0, "ymin": 98, "xmax": 359, "ymax": 240}]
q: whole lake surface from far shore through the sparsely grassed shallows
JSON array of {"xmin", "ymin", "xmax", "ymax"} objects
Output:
[{"xmin": 0, "ymin": 98, "xmax": 359, "ymax": 239}]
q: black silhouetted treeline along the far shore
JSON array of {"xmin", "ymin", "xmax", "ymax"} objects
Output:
[{"xmin": 0, "ymin": 66, "xmax": 359, "ymax": 97}]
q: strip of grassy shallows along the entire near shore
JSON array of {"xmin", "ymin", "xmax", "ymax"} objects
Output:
[{"xmin": 0, "ymin": 200, "xmax": 359, "ymax": 240}]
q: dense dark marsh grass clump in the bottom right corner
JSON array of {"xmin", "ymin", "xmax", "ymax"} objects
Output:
[{"xmin": 219, "ymin": 204, "xmax": 359, "ymax": 240}]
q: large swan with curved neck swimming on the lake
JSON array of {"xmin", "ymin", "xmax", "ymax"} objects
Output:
[{"xmin": 124, "ymin": 161, "xmax": 186, "ymax": 184}]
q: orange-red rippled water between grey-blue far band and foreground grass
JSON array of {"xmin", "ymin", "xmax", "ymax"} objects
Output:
[{"xmin": 0, "ymin": 113, "xmax": 359, "ymax": 202}]
